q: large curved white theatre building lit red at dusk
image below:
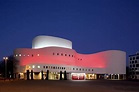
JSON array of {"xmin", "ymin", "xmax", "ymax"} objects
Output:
[{"xmin": 14, "ymin": 36, "xmax": 126, "ymax": 80}]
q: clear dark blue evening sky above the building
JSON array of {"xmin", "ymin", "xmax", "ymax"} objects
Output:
[{"xmin": 0, "ymin": 0, "xmax": 139, "ymax": 62}]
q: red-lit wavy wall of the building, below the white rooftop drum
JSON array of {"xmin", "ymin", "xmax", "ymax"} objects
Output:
[{"xmin": 14, "ymin": 47, "xmax": 126, "ymax": 74}]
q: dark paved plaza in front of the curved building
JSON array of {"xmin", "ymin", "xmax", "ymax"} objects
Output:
[{"xmin": 0, "ymin": 80, "xmax": 139, "ymax": 92}]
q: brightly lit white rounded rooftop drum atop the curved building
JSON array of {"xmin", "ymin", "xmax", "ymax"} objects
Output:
[{"xmin": 32, "ymin": 36, "xmax": 72, "ymax": 49}]
